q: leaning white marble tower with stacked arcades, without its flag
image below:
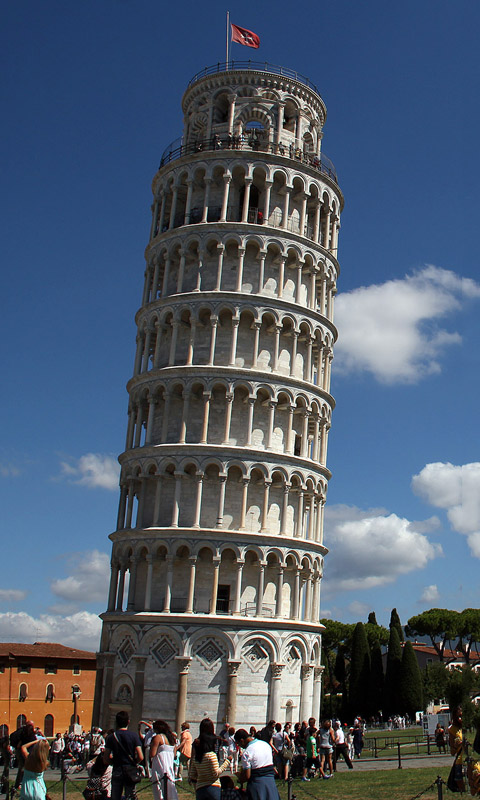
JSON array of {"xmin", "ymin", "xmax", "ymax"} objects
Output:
[{"xmin": 94, "ymin": 62, "xmax": 343, "ymax": 730}]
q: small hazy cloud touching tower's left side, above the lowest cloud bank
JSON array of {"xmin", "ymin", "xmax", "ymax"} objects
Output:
[{"xmin": 50, "ymin": 550, "xmax": 110, "ymax": 608}]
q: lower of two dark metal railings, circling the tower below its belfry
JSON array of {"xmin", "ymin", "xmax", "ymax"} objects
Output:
[{"xmin": 159, "ymin": 134, "xmax": 338, "ymax": 183}]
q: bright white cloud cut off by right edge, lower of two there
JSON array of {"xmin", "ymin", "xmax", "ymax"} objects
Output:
[{"xmin": 412, "ymin": 462, "xmax": 480, "ymax": 558}]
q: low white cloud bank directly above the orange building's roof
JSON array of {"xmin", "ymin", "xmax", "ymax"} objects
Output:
[{"xmin": 0, "ymin": 611, "xmax": 101, "ymax": 651}]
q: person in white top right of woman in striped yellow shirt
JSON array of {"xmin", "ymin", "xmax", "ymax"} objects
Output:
[{"xmin": 235, "ymin": 728, "xmax": 279, "ymax": 800}]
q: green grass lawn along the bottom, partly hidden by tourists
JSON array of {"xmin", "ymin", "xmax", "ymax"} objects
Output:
[{"xmin": 47, "ymin": 762, "xmax": 451, "ymax": 800}]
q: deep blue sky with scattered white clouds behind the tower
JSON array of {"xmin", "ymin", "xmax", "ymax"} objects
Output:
[{"xmin": 0, "ymin": 0, "xmax": 480, "ymax": 648}]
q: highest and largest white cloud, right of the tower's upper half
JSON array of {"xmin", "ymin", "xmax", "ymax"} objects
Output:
[{"xmin": 335, "ymin": 266, "xmax": 480, "ymax": 384}]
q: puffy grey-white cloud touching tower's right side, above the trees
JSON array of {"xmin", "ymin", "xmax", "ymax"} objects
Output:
[{"xmin": 325, "ymin": 505, "xmax": 442, "ymax": 590}]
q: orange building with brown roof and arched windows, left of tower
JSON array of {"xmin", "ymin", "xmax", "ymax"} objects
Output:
[{"xmin": 0, "ymin": 642, "xmax": 96, "ymax": 736}]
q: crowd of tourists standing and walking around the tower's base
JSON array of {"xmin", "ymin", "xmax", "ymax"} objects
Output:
[{"xmin": 1, "ymin": 709, "xmax": 480, "ymax": 800}]
